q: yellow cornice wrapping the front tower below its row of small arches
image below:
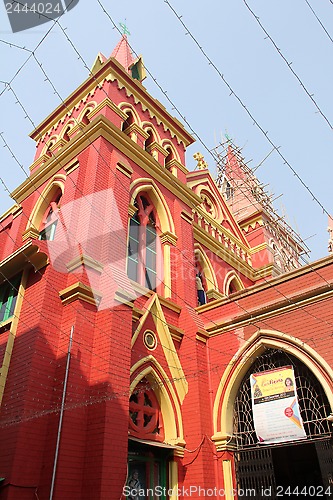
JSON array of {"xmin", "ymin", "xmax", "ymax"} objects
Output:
[{"xmin": 11, "ymin": 115, "xmax": 201, "ymax": 208}]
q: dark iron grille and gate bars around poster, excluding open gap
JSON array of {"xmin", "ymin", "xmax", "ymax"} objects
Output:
[{"xmin": 234, "ymin": 349, "xmax": 333, "ymax": 499}]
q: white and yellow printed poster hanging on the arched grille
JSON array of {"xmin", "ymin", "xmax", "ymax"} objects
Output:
[{"xmin": 250, "ymin": 366, "xmax": 306, "ymax": 444}]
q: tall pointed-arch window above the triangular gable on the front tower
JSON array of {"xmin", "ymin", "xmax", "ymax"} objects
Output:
[{"xmin": 127, "ymin": 195, "xmax": 157, "ymax": 290}]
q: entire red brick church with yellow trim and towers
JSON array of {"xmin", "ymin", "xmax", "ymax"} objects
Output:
[{"xmin": 0, "ymin": 35, "xmax": 333, "ymax": 500}]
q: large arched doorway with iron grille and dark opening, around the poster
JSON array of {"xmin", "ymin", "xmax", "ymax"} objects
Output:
[{"xmin": 234, "ymin": 348, "xmax": 333, "ymax": 499}]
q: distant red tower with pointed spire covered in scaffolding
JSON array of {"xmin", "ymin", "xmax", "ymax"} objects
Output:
[{"xmin": 216, "ymin": 139, "xmax": 307, "ymax": 276}]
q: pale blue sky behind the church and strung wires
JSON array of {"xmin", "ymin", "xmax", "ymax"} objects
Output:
[{"xmin": 0, "ymin": 0, "xmax": 333, "ymax": 260}]
